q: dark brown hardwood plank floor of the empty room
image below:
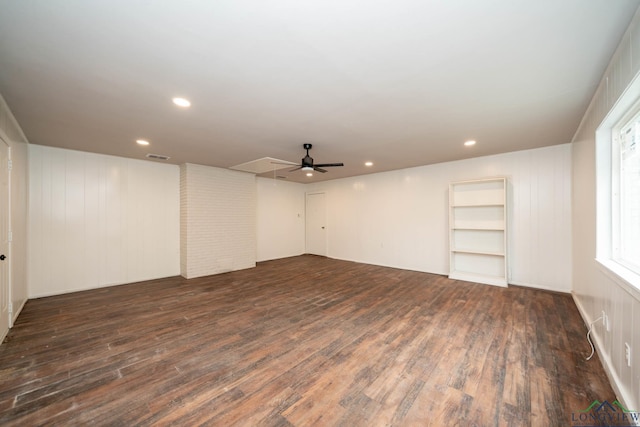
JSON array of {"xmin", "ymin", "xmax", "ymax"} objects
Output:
[{"xmin": 0, "ymin": 256, "xmax": 615, "ymax": 426}]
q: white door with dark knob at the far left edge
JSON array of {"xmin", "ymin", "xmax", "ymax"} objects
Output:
[{"xmin": 0, "ymin": 138, "xmax": 11, "ymax": 343}]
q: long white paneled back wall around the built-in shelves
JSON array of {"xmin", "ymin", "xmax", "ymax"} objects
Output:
[{"xmin": 307, "ymin": 144, "xmax": 571, "ymax": 292}]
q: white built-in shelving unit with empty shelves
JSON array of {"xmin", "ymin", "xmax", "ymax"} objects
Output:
[{"xmin": 449, "ymin": 178, "xmax": 508, "ymax": 286}]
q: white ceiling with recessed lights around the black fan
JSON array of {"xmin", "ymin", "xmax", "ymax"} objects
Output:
[{"xmin": 0, "ymin": 0, "xmax": 640, "ymax": 182}]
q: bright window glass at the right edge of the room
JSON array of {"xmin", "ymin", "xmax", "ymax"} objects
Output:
[{"xmin": 611, "ymin": 111, "xmax": 640, "ymax": 274}]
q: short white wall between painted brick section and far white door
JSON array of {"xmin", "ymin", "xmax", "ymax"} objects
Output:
[{"xmin": 256, "ymin": 177, "xmax": 306, "ymax": 261}]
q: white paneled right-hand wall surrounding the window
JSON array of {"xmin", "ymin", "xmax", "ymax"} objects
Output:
[{"xmin": 572, "ymin": 9, "xmax": 640, "ymax": 410}]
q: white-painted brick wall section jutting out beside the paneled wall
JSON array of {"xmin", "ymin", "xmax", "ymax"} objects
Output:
[{"xmin": 180, "ymin": 164, "xmax": 256, "ymax": 279}]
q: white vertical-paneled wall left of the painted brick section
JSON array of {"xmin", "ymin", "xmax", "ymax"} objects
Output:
[{"xmin": 28, "ymin": 145, "xmax": 180, "ymax": 297}]
